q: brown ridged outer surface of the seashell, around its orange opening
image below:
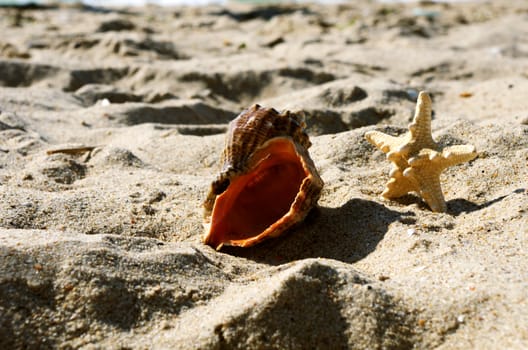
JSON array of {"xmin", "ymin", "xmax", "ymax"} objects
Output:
[{"xmin": 204, "ymin": 104, "xmax": 323, "ymax": 245}]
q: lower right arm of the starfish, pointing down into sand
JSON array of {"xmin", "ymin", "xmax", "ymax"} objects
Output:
[{"xmin": 404, "ymin": 167, "xmax": 447, "ymax": 213}]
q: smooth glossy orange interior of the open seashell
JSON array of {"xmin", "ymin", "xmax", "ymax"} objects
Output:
[{"xmin": 205, "ymin": 138, "xmax": 309, "ymax": 249}]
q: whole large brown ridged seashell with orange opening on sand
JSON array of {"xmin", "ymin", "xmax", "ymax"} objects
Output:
[{"xmin": 204, "ymin": 104, "xmax": 323, "ymax": 250}]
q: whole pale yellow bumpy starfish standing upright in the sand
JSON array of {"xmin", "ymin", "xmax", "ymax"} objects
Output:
[{"xmin": 365, "ymin": 91, "xmax": 477, "ymax": 212}]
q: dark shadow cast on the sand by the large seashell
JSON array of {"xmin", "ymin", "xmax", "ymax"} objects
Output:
[{"xmin": 222, "ymin": 198, "xmax": 416, "ymax": 265}]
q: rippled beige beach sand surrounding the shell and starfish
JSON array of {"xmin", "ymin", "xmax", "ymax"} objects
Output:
[{"xmin": 0, "ymin": 1, "xmax": 528, "ymax": 349}]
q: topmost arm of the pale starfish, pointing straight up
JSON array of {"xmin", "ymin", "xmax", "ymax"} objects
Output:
[{"xmin": 409, "ymin": 91, "xmax": 437, "ymax": 151}]
